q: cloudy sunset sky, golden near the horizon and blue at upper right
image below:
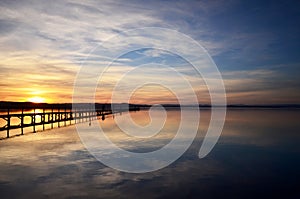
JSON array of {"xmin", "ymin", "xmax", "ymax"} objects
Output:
[{"xmin": 0, "ymin": 0, "xmax": 300, "ymax": 104}]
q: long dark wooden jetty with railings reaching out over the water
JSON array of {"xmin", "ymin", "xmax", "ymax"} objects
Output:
[{"xmin": 0, "ymin": 102, "xmax": 139, "ymax": 138}]
